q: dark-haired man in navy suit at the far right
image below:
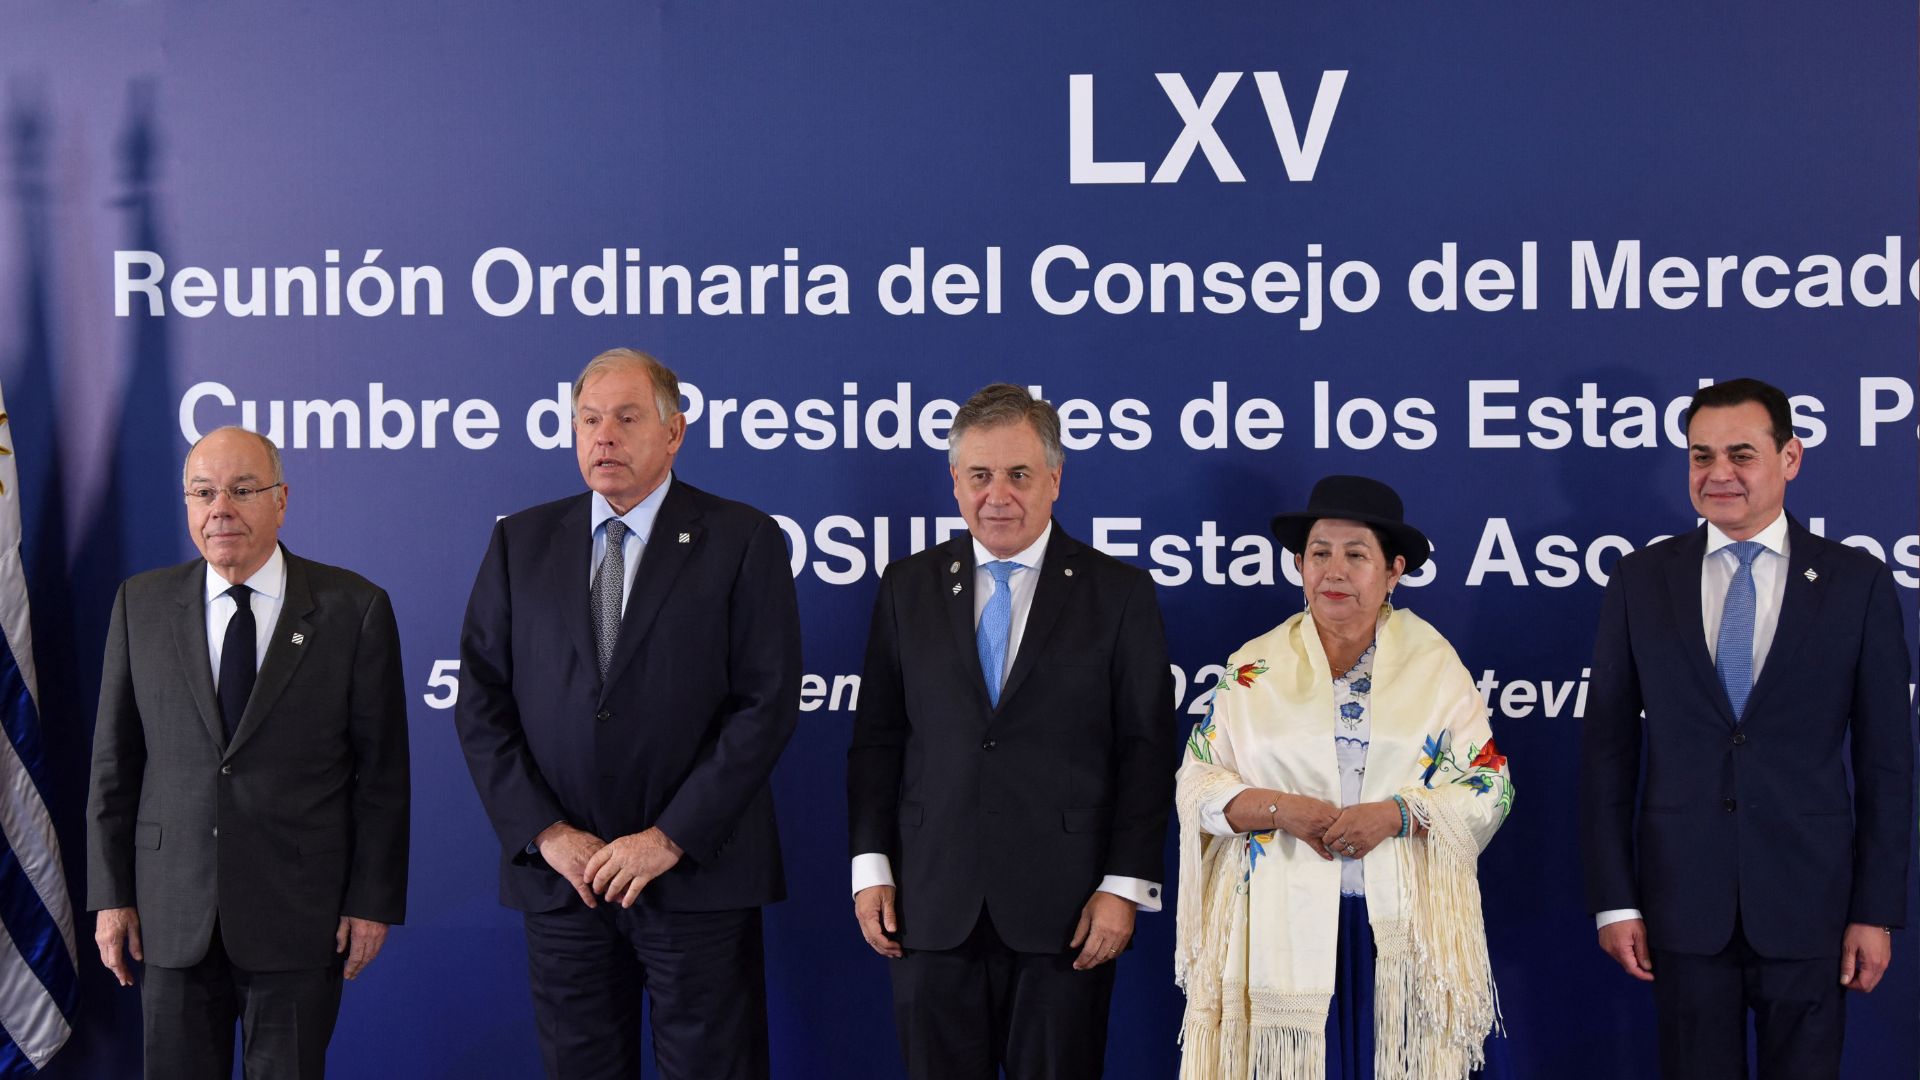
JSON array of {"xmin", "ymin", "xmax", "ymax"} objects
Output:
[{"xmin": 1582, "ymin": 379, "xmax": 1914, "ymax": 1080}]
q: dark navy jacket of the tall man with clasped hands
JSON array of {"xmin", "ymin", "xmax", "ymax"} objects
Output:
[{"xmin": 453, "ymin": 477, "xmax": 801, "ymax": 911}]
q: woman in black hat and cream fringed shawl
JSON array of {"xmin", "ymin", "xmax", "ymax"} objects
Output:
[{"xmin": 1175, "ymin": 477, "xmax": 1513, "ymax": 1080}]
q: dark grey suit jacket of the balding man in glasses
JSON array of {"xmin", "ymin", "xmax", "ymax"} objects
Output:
[{"xmin": 86, "ymin": 552, "xmax": 409, "ymax": 970}]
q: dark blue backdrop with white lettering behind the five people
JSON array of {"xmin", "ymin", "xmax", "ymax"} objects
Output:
[{"xmin": 0, "ymin": 0, "xmax": 1920, "ymax": 1080}]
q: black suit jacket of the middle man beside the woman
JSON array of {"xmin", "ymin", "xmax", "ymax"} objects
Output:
[{"xmin": 847, "ymin": 523, "xmax": 1179, "ymax": 953}]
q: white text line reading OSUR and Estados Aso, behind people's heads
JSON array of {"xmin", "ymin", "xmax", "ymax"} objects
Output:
[{"xmin": 774, "ymin": 513, "xmax": 1920, "ymax": 588}]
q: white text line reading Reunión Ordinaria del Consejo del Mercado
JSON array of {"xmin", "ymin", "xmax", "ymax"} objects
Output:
[{"xmin": 113, "ymin": 236, "xmax": 1920, "ymax": 320}]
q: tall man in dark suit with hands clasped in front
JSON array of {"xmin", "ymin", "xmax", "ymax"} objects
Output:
[{"xmin": 455, "ymin": 350, "xmax": 801, "ymax": 1080}]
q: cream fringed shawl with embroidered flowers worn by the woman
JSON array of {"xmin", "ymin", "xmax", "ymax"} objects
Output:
[{"xmin": 1173, "ymin": 607, "xmax": 1513, "ymax": 1080}]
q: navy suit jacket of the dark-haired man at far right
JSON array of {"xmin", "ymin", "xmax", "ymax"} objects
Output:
[{"xmin": 1582, "ymin": 519, "xmax": 1914, "ymax": 959}]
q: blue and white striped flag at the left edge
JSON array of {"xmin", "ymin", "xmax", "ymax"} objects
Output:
[{"xmin": 0, "ymin": 384, "xmax": 77, "ymax": 1076}]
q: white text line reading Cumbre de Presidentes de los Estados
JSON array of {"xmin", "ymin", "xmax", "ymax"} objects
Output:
[{"xmin": 179, "ymin": 375, "xmax": 1916, "ymax": 452}]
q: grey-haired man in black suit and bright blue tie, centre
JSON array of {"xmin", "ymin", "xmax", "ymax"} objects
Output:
[{"xmin": 847, "ymin": 382, "xmax": 1179, "ymax": 1080}]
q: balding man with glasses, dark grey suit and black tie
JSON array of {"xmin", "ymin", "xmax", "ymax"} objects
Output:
[{"xmin": 86, "ymin": 427, "xmax": 407, "ymax": 1080}]
